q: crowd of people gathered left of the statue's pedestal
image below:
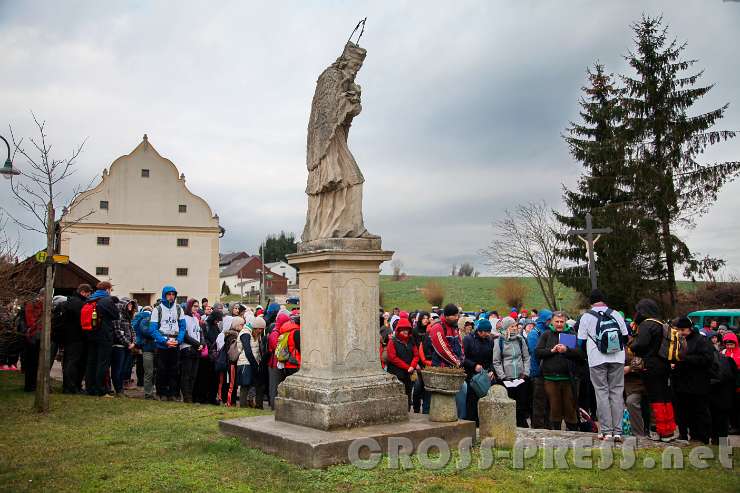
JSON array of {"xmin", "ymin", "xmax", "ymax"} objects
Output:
[{"xmin": 0, "ymin": 281, "xmax": 301, "ymax": 408}]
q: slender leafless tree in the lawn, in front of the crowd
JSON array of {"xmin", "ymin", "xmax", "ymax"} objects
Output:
[{"xmin": 5, "ymin": 113, "xmax": 94, "ymax": 412}]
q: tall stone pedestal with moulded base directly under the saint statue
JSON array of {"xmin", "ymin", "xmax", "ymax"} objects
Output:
[{"xmin": 275, "ymin": 244, "xmax": 408, "ymax": 430}]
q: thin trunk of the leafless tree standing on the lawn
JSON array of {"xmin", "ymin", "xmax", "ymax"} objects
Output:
[{"xmin": 33, "ymin": 202, "xmax": 54, "ymax": 413}]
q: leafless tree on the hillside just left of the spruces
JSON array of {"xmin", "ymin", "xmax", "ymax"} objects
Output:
[{"xmin": 481, "ymin": 202, "xmax": 562, "ymax": 310}]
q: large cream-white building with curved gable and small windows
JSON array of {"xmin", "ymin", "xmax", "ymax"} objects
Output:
[{"xmin": 60, "ymin": 135, "xmax": 223, "ymax": 304}]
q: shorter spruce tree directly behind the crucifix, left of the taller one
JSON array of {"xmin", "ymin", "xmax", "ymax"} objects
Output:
[{"xmin": 556, "ymin": 63, "xmax": 656, "ymax": 308}]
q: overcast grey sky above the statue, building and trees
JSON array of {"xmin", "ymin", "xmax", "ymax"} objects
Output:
[{"xmin": 0, "ymin": 0, "xmax": 740, "ymax": 274}]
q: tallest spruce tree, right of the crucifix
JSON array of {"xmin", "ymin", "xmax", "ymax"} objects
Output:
[{"xmin": 621, "ymin": 16, "xmax": 740, "ymax": 310}]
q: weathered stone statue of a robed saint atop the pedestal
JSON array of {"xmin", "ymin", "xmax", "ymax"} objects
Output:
[{"xmin": 301, "ymin": 41, "xmax": 377, "ymax": 242}]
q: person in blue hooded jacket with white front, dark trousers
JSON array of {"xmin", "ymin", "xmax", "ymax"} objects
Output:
[{"xmin": 149, "ymin": 286, "xmax": 185, "ymax": 401}]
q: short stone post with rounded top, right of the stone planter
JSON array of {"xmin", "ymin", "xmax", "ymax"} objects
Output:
[{"xmin": 476, "ymin": 385, "xmax": 516, "ymax": 448}]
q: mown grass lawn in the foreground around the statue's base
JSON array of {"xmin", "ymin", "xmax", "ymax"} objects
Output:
[{"xmin": 0, "ymin": 372, "xmax": 740, "ymax": 493}]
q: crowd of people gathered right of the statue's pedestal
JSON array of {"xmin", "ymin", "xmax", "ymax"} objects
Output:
[{"xmin": 379, "ymin": 290, "xmax": 740, "ymax": 444}]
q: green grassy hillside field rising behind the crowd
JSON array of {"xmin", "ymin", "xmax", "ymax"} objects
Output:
[{"xmin": 380, "ymin": 276, "xmax": 697, "ymax": 313}]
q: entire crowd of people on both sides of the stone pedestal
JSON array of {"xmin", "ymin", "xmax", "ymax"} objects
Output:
[{"xmin": 0, "ymin": 282, "xmax": 740, "ymax": 444}]
